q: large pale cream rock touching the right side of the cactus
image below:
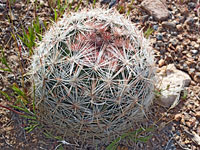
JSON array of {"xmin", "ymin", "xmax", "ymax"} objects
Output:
[{"xmin": 156, "ymin": 64, "xmax": 191, "ymax": 108}]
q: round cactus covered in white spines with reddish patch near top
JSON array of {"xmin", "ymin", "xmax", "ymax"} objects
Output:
[{"xmin": 31, "ymin": 9, "xmax": 155, "ymax": 143}]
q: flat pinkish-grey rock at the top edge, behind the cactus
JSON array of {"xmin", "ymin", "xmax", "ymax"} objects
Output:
[{"xmin": 141, "ymin": 0, "xmax": 169, "ymax": 21}]
